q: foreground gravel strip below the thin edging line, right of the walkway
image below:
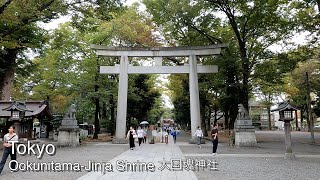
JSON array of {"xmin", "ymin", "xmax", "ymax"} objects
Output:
[{"xmin": 186, "ymin": 157, "xmax": 320, "ymax": 180}]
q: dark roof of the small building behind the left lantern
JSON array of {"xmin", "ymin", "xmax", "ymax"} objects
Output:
[{"xmin": 0, "ymin": 100, "xmax": 53, "ymax": 118}]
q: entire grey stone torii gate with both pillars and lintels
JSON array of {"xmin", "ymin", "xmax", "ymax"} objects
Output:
[{"xmin": 91, "ymin": 44, "xmax": 226, "ymax": 143}]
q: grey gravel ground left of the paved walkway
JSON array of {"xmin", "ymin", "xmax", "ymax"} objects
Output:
[{"xmin": 0, "ymin": 142, "xmax": 128, "ymax": 180}]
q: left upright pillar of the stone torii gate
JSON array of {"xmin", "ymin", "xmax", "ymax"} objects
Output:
[{"xmin": 113, "ymin": 56, "xmax": 129, "ymax": 143}]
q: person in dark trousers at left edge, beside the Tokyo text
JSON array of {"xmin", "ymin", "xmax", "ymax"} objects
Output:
[{"xmin": 0, "ymin": 126, "xmax": 19, "ymax": 174}]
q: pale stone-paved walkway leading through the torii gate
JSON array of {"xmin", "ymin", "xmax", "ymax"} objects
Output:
[{"xmin": 79, "ymin": 136, "xmax": 197, "ymax": 180}]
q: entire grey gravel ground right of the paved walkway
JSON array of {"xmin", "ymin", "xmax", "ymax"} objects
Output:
[{"xmin": 178, "ymin": 131, "xmax": 320, "ymax": 180}]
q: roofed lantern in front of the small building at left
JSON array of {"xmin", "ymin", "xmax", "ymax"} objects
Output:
[{"xmin": 3, "ymin": 101, "xmax": 32, "ymax": 136}]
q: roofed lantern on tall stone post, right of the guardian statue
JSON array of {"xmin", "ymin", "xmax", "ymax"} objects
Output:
[{"xmin": 272, "ymin": 101, "xmax": 299, "ymax": 159}]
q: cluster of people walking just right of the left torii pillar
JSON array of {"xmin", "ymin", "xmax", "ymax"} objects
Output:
[{"xmin": 127, "ymin": 126, "xmax": 147, "ymax": 150}]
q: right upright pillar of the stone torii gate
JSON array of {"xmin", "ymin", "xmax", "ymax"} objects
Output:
[{"xmin": 189, "ymin": 55, "xmax": 201, "ymax": 139}]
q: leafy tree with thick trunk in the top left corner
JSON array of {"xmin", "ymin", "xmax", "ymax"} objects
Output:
[{"xmin": 0, "ymin": 0, "xmax": 67, "ymax": 100}]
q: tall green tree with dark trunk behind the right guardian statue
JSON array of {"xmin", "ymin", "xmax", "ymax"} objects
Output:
[{"xmin": 143, "ymin": 0, "xmax": 296, "ymax": 129}]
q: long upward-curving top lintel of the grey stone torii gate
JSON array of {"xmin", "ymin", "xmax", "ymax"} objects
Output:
[{"xmin": 91, "ymin": 44, "xmax": 227, "ymax": 57}]
